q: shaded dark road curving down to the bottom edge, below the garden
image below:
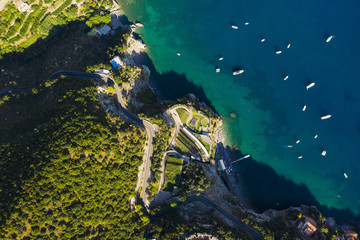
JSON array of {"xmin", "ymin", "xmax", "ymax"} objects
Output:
[{"xmin": 150, "ymin": 196, "xmax": 264, "ymax": 240}]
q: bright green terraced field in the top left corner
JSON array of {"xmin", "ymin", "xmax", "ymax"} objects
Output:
[{"xmin": 0, "ymin": 0, "xmax": 112, "ymax": 59}]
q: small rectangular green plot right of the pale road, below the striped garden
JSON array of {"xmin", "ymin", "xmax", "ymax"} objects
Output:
[{"xmin": 164, "ymin": 157, "xmax": 183, "ymax": 192}]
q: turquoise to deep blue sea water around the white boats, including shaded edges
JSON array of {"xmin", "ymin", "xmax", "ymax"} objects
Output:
[{"xmin": 120, "ymin": 0, "xmax": 360, "ymax": 219}]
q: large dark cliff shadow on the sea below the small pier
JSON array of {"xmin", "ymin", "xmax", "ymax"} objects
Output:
[{"xmin": 228, "ymin": 149, "xmax": 360, "ymax": 222}]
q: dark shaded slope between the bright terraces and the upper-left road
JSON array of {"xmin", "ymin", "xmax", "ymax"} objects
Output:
[{"xmin": 0, "ymin": 21, "xmax": 126, "ymax": 91}]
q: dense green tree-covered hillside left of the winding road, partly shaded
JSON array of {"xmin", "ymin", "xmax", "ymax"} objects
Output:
[{"xmin": 0, "ymin": 78, "xmax": 149, "ymax": 239}]
